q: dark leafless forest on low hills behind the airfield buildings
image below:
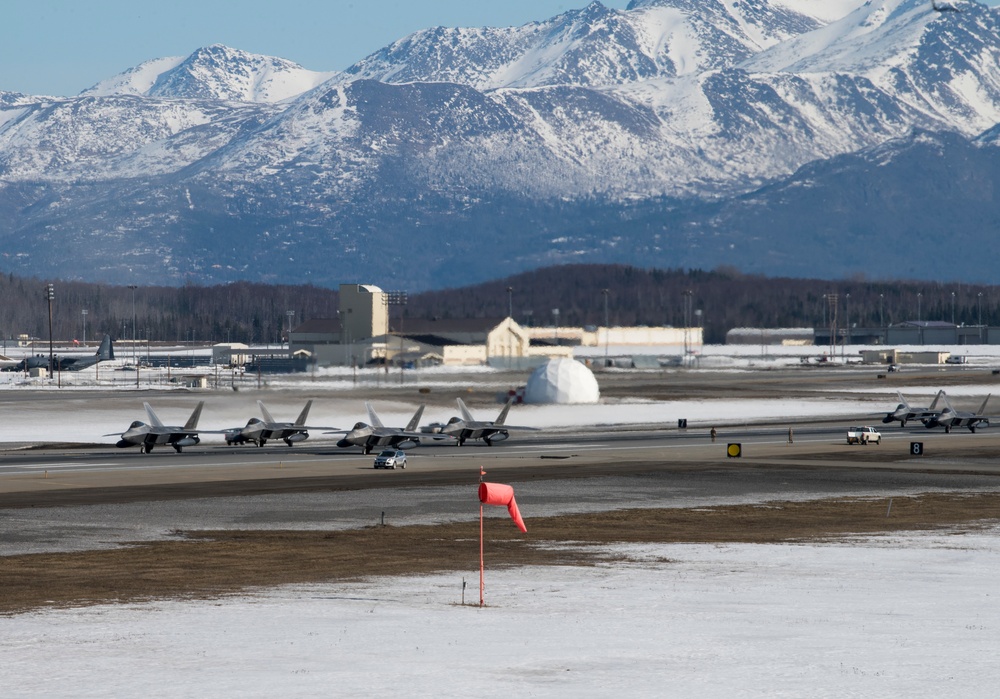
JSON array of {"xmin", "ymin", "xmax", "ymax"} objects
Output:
[{"xmin": 0, "ymin": 265, "xmax": 1000, "ymax": 343}]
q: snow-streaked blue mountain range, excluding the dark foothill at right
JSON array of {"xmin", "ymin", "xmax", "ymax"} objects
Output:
[{"xmin": 0, "ymin": 0, "xmax": 1000, "ymax": 288}]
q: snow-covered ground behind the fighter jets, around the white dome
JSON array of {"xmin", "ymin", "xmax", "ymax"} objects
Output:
[{"xmin": 0, "ymin": 345, "xmax": 1000, "ymax": 443}]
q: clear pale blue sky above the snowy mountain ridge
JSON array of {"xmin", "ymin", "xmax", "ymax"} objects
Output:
[{"xmin": 0, "ymin": 0, "xmax": 1000, "ymax": 95}]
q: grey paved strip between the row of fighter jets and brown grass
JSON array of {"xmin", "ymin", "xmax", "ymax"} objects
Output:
[{"xmin": 0, "ymin": 425, "xmax": 1000, "ymax": 555}]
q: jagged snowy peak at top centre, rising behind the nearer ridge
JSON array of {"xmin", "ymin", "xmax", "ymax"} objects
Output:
[{"xmin": 345, "ymin": 0, "xmax": 821, "ymax": 90}]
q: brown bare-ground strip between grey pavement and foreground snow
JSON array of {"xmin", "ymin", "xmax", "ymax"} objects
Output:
[{"xmin": 0, "ymin": 493, "xmax": 1000, "ymax": 614}]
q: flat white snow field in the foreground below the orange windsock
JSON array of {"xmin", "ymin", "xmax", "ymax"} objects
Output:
[{"xmin": 0, "ymin": 532, "xmax": 1000, "ymax": 699}]
